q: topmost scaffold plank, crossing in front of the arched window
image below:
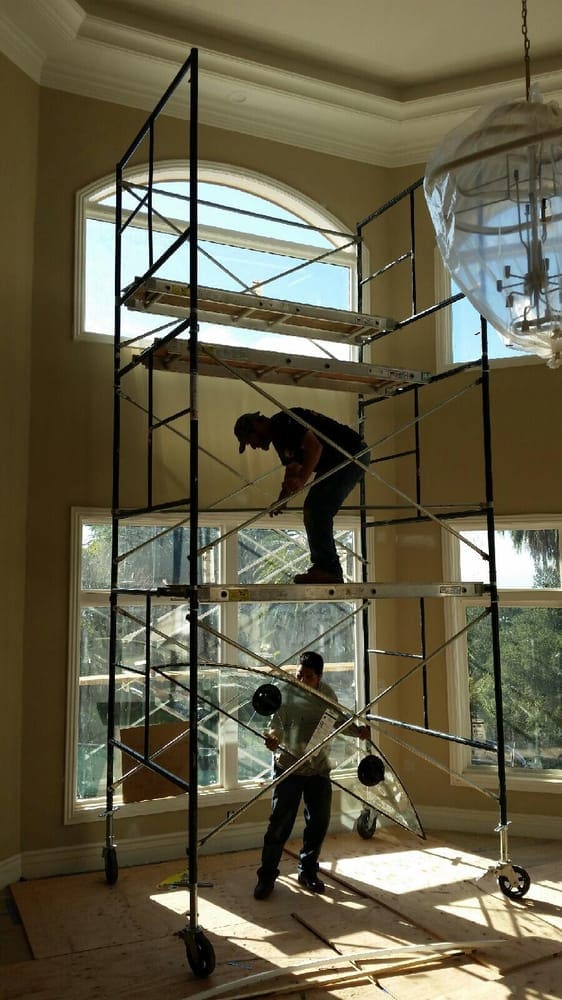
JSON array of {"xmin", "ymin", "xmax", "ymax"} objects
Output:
[{"xmin": 124, "ymin": 278, "xmax": 397, "ymax": 344}]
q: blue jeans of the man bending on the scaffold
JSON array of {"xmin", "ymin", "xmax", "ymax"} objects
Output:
[{"xmin": 303, "ymin": 451, "xmax": 370, "ymax": 577}]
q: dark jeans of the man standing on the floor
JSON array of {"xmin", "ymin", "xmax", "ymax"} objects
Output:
[{"xmin": 258, "ymin": 772, "xmax": 332, "ymax": 882}]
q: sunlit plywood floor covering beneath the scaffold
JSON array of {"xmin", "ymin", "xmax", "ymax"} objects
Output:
[{"xmin": 0, "ymin": 830, "xmax": 562, "ymax": 1000}]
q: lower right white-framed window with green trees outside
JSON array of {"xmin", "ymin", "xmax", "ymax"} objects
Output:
[{"xmin": 446, "ymin": 518, "xmax": 562, "ymax": 785}]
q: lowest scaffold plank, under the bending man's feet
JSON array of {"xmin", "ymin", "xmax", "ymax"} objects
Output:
[{"xmin": 157, "ymin": 582, "xmax": 489, "ymax": 604}]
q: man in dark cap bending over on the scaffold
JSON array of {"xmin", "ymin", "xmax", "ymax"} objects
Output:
[{"xmin": 234, "ymin": 406, "xmax": 370, "ymax": 583}]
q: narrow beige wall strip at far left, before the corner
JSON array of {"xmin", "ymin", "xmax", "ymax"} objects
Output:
[{"xmin": 0, "ymin": 56, "xmax": 39, "ymax": 862}]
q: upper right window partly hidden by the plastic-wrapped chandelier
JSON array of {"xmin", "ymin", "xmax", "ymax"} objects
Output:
[{"xmin": 435, "ymin": 252, "xmax": 531, "ymax": 365}]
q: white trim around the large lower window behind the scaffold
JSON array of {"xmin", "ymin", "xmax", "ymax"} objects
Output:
[{"xmin": 64, "ymin": 507, "xmax": 363, "ymax": 825}]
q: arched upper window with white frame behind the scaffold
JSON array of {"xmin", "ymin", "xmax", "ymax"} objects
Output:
[{"xmin": 75, "ymin": 162, "xmax": 356, "ymax": 360}]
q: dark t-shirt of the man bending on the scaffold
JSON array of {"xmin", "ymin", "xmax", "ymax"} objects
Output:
[{"xmin": 270, "ymin": 406, "xmax": 365, "ymax": 475}]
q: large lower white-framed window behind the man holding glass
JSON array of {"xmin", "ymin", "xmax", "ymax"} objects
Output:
[{"xmin": 67, "ymin": 510, "xmax": 360, "ymax": 821}]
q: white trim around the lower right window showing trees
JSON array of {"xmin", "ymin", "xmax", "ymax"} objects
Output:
[{"xmin": 443, "ymin": 514, "xmax": 562, "ymax": 794}]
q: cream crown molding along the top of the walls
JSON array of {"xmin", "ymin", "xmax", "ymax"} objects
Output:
[{"xmin": 0, "ymin": 0, "xmax": 562, "ymax": 167}]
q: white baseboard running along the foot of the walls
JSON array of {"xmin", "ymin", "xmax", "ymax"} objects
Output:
[{"xmin": 0, "ymin": 806, "xmax": 562, "ymax": 886}]
